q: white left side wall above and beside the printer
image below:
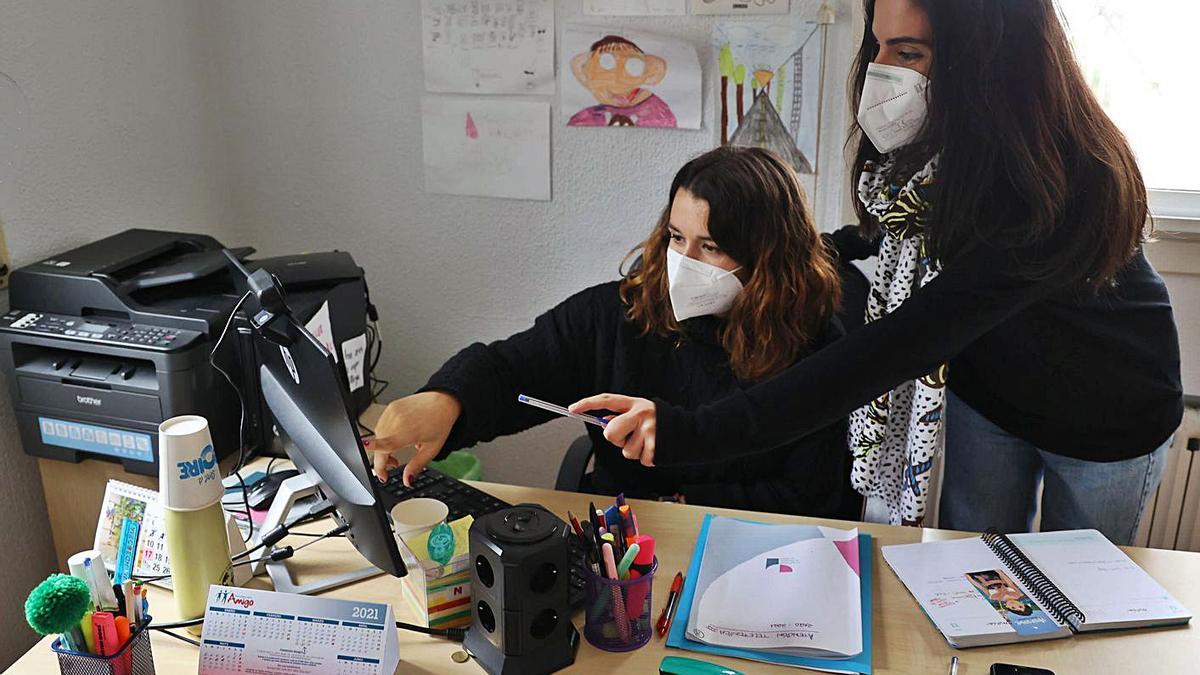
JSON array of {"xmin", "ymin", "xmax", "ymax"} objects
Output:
[{"xmin": 0, "ymin": 0, "xmax": 233, "ymax": 669}]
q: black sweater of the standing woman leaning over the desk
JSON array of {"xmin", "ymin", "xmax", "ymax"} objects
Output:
[{"xmin": 655, "ymin": 228, "xmax": 1183, "ymax": 466}]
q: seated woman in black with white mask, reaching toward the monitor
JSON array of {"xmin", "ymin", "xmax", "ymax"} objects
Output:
[{"xmin": 366, "ymin": 147, "xmax": 860, "ymax": 518}]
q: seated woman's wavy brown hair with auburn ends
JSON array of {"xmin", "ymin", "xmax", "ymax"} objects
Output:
[{"xmin": 620, "ymin": 147, "xmax": 841, "ymax": 381}]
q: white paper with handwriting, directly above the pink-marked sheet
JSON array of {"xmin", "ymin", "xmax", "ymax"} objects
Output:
[{"xmin": 421, "ymin": 0, "xmax": 554, "ymax": 94}]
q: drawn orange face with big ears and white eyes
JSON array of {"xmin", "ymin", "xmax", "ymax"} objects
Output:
[{"xmin": 571, "ymin": 35, "xmax": 667, "ymax": 108}]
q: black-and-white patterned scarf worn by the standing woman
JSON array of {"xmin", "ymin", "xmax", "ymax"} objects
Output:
[{"xmin": 850, "ymin": 155, "xmax": 946, "ymax": 525}]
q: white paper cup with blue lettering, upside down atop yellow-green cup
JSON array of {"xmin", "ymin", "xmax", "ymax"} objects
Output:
[{"xmin": 158, "ymin": 414, "xmax": 224, "ymax": 510}]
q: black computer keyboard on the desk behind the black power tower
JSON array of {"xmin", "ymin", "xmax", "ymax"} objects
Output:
[{"xmin": 383, "ymin": 468, "xmax": 587, "ymax": 608}]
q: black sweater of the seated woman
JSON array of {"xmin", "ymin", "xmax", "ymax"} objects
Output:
[{"xmin": 424, "ymin": 281, "xmax": 859, "ymax": 518}]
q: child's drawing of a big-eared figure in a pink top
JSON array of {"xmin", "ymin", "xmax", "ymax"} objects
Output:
[{"xmin": 559, "ymin": 26, "xmax": 701, "ymax": 129}]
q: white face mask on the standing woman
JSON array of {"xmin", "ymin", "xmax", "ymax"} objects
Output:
[{"xmin": 858, "ymin": 64, "xmax": 929, "ymax": 153}]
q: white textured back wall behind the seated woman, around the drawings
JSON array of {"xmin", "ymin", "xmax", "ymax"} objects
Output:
[{"xmin": 205, "ymin": 0, "xmax": 852, "ymax": 485}]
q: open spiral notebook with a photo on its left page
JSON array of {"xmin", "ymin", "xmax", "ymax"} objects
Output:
[{"xmin": 882, "ymin": 530, "xmax": 1192, "ymax": 647}]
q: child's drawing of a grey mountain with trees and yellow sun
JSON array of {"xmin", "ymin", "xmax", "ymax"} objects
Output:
[{"xmin": 714, "ymin": 19, "xmax": 824, "ymax": 173}]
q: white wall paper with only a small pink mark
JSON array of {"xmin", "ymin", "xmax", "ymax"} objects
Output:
[{"xmin": 421, "ymin": 96, "xmax": 550, "ymax": 201}]
